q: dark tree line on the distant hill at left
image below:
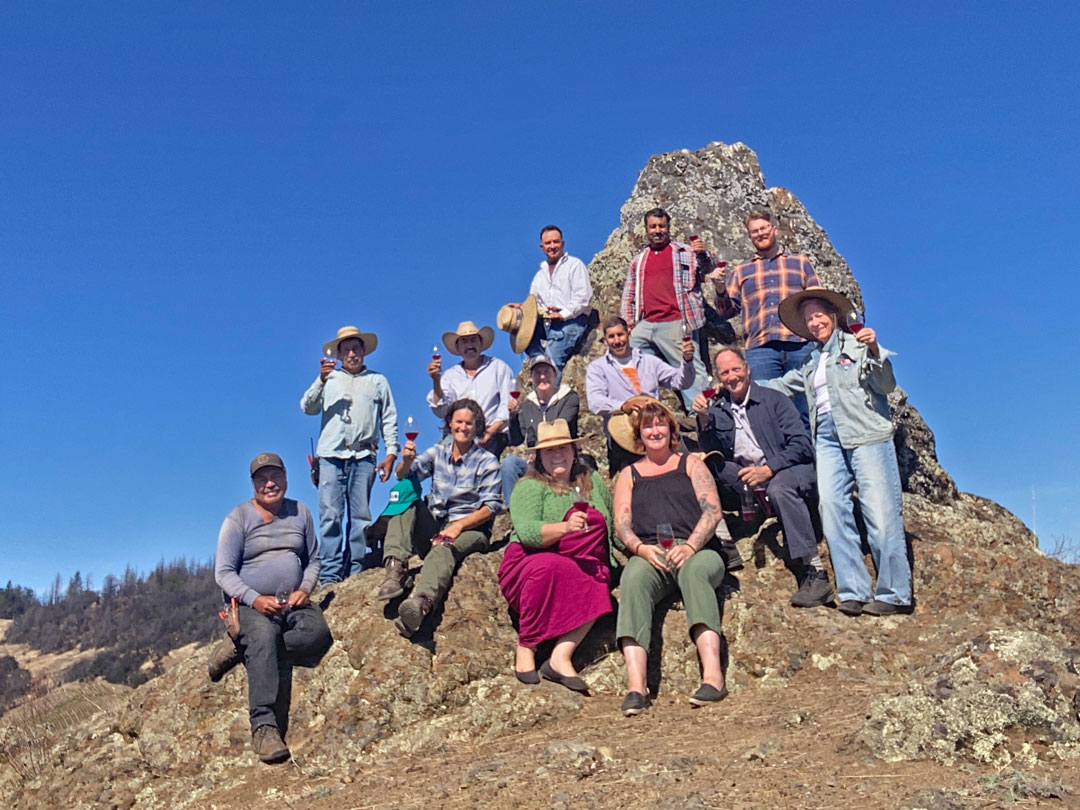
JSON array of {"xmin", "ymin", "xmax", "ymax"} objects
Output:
[{"xmin": 0, "ymin": 558, "xmax": 221, "ymax": 712}]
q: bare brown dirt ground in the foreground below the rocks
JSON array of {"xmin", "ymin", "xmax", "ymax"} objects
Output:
[{"xmin": 203, "ymin": 667, "xmax": 1080, "ymax": 810}]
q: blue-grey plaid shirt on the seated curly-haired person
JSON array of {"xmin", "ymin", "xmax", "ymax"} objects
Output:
[{"xmin": 410, "ymin": 442, "xmax": 503, "ymax": 521}]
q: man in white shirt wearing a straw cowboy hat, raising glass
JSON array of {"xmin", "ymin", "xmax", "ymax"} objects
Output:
[{"xmin": 428, "ymin": 321, "xmax": 514, "ymax": 457}]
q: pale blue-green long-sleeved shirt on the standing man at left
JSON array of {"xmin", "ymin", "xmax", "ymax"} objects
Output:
[{"xmin": 300, "ymin": 366, "xmax": 400, "ymax": 458}]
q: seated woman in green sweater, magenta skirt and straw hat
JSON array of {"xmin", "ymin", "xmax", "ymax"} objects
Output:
[{"xmin": 499, "ymin": 419, "xmax": 613, "ymax": 693}]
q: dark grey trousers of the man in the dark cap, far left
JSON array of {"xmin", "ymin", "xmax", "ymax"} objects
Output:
[{"xmin": 237, "ymin": 605, "xmax": 334, "ymax": 737}]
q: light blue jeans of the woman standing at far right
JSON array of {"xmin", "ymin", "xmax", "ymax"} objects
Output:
[{"xmin": 814, "ymin": 414, "xmax": 912, "ymax": 605}]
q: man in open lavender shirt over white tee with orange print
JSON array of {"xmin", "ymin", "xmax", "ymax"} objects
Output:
[{"xmin": 585, "ymin": 315, "xmax": 694, "ymax": 477}]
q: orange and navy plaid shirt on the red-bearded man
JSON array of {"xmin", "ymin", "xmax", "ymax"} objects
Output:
[{"xmin": 716, "ymin": 251, "xmax": 821, "ymax": 349}]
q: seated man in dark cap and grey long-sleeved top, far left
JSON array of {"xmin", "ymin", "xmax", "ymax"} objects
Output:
[{"xmin": 207, "ymin": 453, "xmax": 334, "ymax": 764}]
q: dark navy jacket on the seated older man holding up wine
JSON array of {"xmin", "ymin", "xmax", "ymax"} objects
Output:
[{"xmin": 699, "ymin": 382, "xmax": 813, "ymax": 486}]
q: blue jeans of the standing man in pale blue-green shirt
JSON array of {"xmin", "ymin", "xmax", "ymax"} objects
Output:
[{"xmin": 319, "ymin": 456, "xmax": 375, "ymax": 582}]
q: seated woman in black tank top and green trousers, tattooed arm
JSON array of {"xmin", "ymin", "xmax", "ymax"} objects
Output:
[{"xmin": 615, "ymin": 401, "xmax": 728, "ymax": 716}]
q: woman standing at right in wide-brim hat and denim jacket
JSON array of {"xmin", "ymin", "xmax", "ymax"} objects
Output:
[{"xmin": 760, "ymin": 287, "xmax": 913, "ymax": 616}]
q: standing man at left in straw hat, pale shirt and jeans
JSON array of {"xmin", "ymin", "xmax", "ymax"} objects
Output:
[{"xmin": 300, "ymin": 326, "xmax": 399, "ymax": 583}]
